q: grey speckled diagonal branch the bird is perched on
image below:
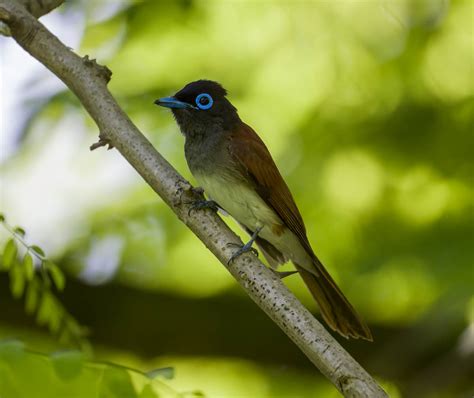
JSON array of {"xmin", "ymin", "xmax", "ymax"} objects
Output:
[{"xmin": 0, "ymin": 0, "xmax": 387, "ymax": 397}]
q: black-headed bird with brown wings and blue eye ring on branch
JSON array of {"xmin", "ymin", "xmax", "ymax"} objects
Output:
[{"xmin": 155, "ymin": 79, "xmax": 373, "ymax": 341}]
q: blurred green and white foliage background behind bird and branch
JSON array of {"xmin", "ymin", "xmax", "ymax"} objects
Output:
[{"xmin": 0, "ymin": 0, "xmax": 474, "ymax": 398}]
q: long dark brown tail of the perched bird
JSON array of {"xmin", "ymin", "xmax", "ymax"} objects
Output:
[{"xmin": 295, "ymin": 259, "xmax": 373, "ymax": 341}]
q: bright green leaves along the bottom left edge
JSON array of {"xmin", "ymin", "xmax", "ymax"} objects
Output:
[{"xmin": 0, "ymin": 340, "xmax": 202, "ymax": 398}]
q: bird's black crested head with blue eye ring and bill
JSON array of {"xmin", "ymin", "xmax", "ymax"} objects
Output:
[{"xmin": 155, "ymin": 80, "xmax": 240, "ymax": 136}]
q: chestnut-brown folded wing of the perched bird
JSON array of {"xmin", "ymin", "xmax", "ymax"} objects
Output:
[{"xmin": 229, "ymin": 123, "xmax": 315, "ymax": 258}]
